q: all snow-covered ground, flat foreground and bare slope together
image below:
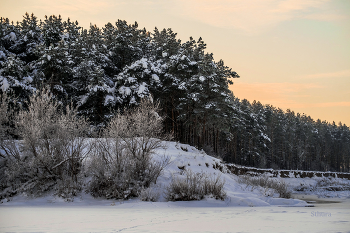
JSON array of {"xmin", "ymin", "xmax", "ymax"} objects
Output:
[{"xmin": 0, "ymin": 142, "xmax": 350, "ymax": 232}]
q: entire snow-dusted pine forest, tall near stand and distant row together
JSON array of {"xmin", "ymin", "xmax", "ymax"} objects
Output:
[{"xmin": 0, "ymin": 14, "xmax": 350, "ymax": 172}]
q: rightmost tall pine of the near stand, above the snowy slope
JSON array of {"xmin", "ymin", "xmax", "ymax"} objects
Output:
[{"xmin": 176, "ymin": 38, "xmax": 239, "ymax": 153}]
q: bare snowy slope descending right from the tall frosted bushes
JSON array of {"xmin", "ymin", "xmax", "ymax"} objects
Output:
[{"xmin": 156, "ymin": 142, "xmax": 307, "ymax": 206}]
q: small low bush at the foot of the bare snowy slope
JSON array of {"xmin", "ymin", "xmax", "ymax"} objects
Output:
[{"xmin": 165, "ymin": 170, "xmax": 226, "ymax": 201}]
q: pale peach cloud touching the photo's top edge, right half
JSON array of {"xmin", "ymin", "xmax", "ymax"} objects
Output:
[{"xmin": 173, "ymin": 0, "xmax": 347, "ymax": 34}]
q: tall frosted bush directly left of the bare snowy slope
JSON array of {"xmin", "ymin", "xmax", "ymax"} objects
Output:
[{"xmin": 88, "ymin": 100, "xmax": 169, "ymax": 199}]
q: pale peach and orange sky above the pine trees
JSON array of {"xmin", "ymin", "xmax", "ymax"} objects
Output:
[{"xmin": 0, "ymin": 0, "xmax": 350, "ymax": 126}]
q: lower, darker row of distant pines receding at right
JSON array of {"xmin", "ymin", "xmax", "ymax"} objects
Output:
[{"xmin": 225, "ymin": 99, "xmax": 350, "ymax": 172}]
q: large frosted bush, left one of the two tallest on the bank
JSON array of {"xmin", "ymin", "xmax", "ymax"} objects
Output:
[{"xmin": 1, "ymin": 88, "xmax": 89, "ymax": 196}]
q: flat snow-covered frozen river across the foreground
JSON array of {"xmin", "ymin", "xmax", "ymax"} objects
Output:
[{"xmin": 0, "ymin": 197, "xmax": 350, "ymax": 233}]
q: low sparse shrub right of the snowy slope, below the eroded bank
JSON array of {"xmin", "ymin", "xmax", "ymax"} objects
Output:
[{"xmin": 238, "ymin": 175, "xmax": 291, "ymax": 198}]
